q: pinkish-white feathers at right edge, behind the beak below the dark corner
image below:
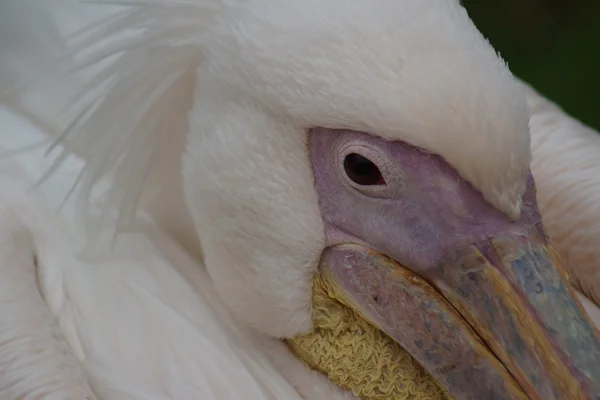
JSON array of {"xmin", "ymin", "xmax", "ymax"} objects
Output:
[{"xmin": 523, "ymin": 84, "xmax": 600, "ymax": 305}]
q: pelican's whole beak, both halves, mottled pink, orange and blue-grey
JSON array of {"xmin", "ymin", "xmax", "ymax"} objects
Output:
[{"xmin": 320, "ymin": 228, "xmax": 600, "ymax": 400}]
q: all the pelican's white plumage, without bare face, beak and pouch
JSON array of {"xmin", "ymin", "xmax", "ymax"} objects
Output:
[{"xmin": 0, "ymin": 0, "xmax": 600, "ymax": 400}]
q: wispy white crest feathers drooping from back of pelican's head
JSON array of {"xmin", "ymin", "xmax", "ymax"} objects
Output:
[{"xmin": 0, "ymin": 0, "xmax": 228, "ymax": 242}]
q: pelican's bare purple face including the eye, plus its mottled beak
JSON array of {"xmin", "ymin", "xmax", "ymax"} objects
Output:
[{"xmin": 310, "ymin": 128, "xmax": 600, "ymax": 400}]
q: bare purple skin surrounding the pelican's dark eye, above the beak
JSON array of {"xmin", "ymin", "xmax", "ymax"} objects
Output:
[{"xmin": 310, "ymin": 128, "xmax": 541, "ymax": 272}]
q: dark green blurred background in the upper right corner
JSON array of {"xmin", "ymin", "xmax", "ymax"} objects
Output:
[{"xmin": 463, "ymin": 0, "xmax": 600, "ymax": 129}]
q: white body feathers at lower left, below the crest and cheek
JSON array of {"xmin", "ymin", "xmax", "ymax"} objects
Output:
[{"xmin": 0, "ymin": 111, "xmax": 351, "ymax": 400}]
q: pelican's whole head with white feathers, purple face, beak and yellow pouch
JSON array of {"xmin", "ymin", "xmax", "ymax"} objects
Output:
[{"xmin": 7, "ymin": 0, "xmax": 600, "ymax": 400}]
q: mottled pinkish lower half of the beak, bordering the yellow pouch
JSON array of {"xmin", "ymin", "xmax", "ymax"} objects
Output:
[{"xmin": 321, "ymin": 245, "xmax": 527, "ymax": 400}]
